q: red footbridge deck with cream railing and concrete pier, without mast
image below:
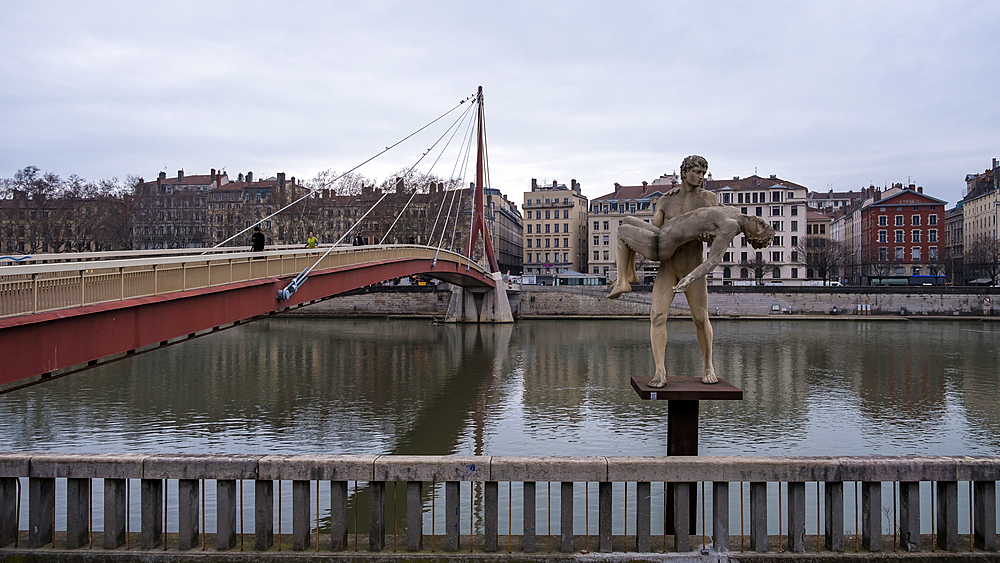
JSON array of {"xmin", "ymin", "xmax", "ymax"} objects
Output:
[{"xmin": 0, "ymin": 245, "xmax": 512, "ymax": 387}]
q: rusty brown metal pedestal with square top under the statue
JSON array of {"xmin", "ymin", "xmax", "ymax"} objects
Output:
[{"xmin": 632, "ymin": 377, "xmax": 743, "ymax": 534}]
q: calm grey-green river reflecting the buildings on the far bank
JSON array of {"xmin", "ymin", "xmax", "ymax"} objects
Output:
[{"xmin": 0, "ymin": 319, "xmax": 1000, "ymax": 533}]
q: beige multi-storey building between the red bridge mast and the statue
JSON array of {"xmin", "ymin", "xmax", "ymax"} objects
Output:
[{"xmin": 524, "ymin": 178, "xmax": 587, "ymax": 283}]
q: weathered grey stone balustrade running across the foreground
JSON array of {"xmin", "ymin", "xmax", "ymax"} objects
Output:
[{"xmin": 0, "ymin": 453, "xmax": 1000, "ymax": 556}]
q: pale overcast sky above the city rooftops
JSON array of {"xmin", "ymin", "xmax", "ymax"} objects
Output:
[{"xmin": 0, "ymin": 0, "xmax": 1000, "ymax": 205}]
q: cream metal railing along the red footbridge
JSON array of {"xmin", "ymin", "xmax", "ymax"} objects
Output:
[{"xmin": 0, "ymin": 245, "xmax": 485, "ymax": 318}]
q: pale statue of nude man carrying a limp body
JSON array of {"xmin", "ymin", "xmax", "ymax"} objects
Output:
[{"xmin": 608, "ymin": 155, "xmax": 774, "ymax": 387}]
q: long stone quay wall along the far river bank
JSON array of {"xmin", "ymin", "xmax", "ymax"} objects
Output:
[{"xmin": 284, "ymin": 284, "xmax": 1000, "ymax": 318}]
